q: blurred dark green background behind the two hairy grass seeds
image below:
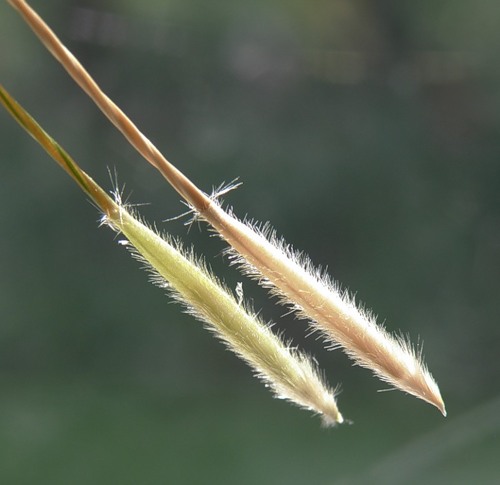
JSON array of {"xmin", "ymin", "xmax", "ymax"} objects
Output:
[{"xmin": 0, "ymin": 0, "xmax": 500, "ymax": 485}]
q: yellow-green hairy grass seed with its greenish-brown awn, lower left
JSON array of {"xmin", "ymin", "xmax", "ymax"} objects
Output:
[{"xmin": 0, "ymin": 86, "xmax": 343, "ymax": 426}]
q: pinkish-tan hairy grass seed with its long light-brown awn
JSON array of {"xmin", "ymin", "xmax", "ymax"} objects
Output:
[{"xmin": 9, "ymin": 0, "xmax": 446, "ymax": 415}]
